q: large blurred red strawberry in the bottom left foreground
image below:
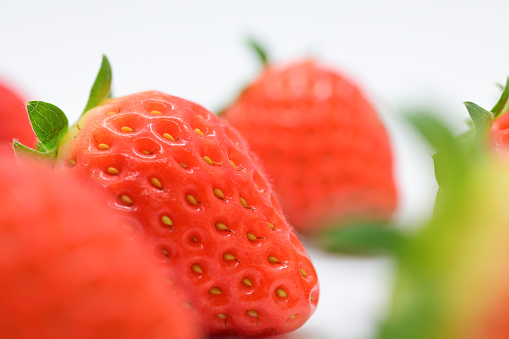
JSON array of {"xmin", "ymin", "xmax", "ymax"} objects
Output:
[{"xmin": 0, "ymin": 155, "xmax": 197, "ymax": 339}]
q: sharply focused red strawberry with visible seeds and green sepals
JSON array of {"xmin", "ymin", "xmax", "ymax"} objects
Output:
[{"xmin": 15, "ymin": 58, "xmax": 319, "ymax": 335}]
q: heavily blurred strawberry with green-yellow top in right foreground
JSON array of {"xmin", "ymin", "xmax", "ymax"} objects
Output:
[{"xmin": 322, "ymin": 87, "xmax": 509, "ymax": 339}]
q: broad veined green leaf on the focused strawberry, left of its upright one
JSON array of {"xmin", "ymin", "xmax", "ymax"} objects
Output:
[{"xmin": 27, "ymin": 101, "xmax": 69, "ymax": 155}]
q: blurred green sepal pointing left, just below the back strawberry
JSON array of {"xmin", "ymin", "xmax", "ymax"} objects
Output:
[{"xmin": 318, "ymin": 223, "xmax": 406, "ymax": 254}]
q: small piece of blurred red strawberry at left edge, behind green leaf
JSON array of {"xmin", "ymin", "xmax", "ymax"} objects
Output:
[{"xmin": 0, "ymin": 82, "xmax": 35, "ymax": 154}]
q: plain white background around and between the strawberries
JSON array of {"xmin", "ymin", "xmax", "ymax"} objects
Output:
[{"xmin": 0, "ymin": 0, "xmax": 509, "ymax": 339}]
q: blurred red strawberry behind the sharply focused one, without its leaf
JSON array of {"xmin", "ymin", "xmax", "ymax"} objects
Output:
[{"xmin": 223, "ymin": 61, "xmax": 397, "ymax": 232}]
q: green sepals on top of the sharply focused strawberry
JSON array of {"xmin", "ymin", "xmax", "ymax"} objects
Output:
[{"xmin": 13, "ymin": 56, "xmax": 112, "ymax": 160}]
